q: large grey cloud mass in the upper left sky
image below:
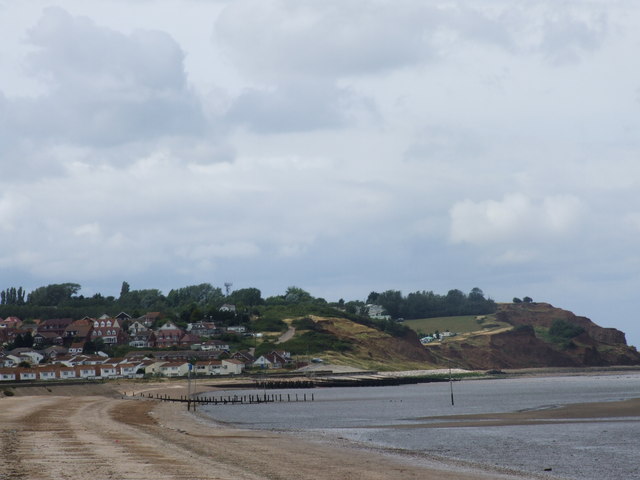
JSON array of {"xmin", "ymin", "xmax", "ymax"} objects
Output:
[{"xmin": 9, "ymin": 7, "xmax": 204, "ymax": 146}]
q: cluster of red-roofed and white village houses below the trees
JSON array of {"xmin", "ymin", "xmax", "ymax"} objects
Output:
[{"xmin": 0, "ymin": 305, "xmax": 292, "ymax": 382}]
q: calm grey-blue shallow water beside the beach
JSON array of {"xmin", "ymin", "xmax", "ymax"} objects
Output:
[{"xmin": 202, "ymin": 373, "xmax": 640, "ymax": 480}]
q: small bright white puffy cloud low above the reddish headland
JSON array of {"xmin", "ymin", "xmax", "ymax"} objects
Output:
[{"xmin": 450, "ymin": 193, "xmax": 583, "ymax": 248}]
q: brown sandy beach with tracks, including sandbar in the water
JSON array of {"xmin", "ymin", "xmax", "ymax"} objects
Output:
[{"xmin": 0, "ymin": 382, "xmax": 640, "ymax": 480}]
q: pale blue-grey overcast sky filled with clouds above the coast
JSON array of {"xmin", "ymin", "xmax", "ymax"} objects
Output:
[{"xmin": 0, "ymin": 0, "xmax": 640, "ymax": 346}]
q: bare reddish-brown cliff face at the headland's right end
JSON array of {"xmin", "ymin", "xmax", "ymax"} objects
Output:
[{"xmin": 428, "ymin": 303, "xmax": 640, "ymax": 369}]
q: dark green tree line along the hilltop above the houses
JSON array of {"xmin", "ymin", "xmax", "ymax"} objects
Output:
[{"xmin": 0, "ymin": 281, "xmax": 496, "ymax": 328}]
